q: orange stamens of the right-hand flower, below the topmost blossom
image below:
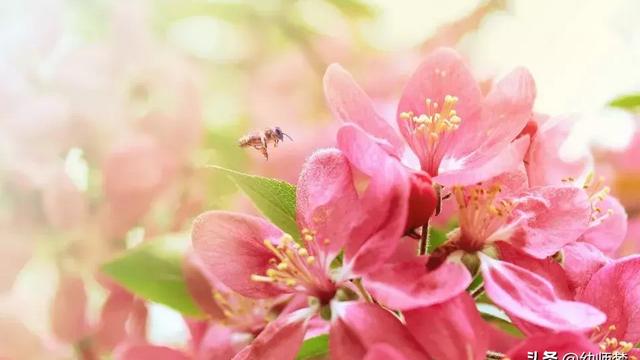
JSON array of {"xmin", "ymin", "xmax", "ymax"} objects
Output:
[{"xmin": 452, "ymin": 184, "xmax": 514, "ymax": 252}]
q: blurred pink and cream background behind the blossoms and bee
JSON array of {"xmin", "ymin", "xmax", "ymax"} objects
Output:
[{"xmin": 0, "ymin": 0, "xmax": 640, "ymax": 359}]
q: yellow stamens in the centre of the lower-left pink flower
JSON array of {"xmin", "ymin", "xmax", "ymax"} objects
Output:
[{"xmin": 251, "ymin": 229, "xmax": 335, "ymax": 301}]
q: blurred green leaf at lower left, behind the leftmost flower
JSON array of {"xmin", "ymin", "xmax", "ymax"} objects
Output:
[{"xmin": 102, "ymin": 234, "xmax": 203, "ymax": 316}]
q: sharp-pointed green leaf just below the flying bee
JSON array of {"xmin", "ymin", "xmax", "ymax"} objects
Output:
[{"xmin": 211, "ymin": 166, "xmax": 300, "ymax": 239}]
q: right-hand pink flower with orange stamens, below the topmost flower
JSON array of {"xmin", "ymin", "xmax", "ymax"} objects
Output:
[{"xmin": 365, "ymin": 170, "xmax": 605, "ymax": 331}]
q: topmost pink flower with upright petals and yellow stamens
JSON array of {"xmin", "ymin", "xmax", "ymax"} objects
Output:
[{"xmin": 324, "ymin": 49, "xmax": 535, "ymax": 185}]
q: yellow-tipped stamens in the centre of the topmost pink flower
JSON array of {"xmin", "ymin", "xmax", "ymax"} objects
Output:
[{"xmin": 400, "ymin": 95, "xmax": 462, "ymax": 176}]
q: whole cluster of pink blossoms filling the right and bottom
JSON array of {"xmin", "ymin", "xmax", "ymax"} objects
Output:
[{"xmin": 130, "ymin": 49, "xmax": 640, "ymax": 360}]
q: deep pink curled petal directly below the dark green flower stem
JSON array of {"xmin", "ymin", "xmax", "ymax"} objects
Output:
[{"xmin": 364, "ymin": 257, "xmax": 471, "ymax": 311}]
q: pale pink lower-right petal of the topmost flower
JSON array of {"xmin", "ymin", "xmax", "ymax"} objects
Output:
[{"xmin": 433, "ymin": 136, "xmax": 529, "ymax": 186}]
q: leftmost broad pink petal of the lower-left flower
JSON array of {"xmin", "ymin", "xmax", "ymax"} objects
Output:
[{"xmin": 191, "ymin": 211, "xmax": 283, "ymax": 298}]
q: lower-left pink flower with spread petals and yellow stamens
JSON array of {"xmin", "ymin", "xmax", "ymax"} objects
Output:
[{"xmin": 193, "ymin": 148, "xmax": 424, "ymax": 359}]
